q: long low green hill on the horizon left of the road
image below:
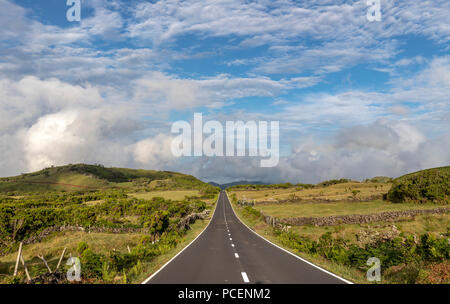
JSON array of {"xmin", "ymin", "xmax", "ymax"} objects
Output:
[{"xmin": 0, "ymin": 164, "xmax": 215, "ymax": 192}]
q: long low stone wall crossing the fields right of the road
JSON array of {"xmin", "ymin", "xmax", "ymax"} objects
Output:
[{"xmin": 261, "ymin": 208, "xmax": 450, "ymax": 227}]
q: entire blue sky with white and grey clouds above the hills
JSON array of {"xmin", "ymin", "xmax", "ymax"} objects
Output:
[{"xmin": 0, "ymin": 0, "xmax": 450, "ymax": 182}]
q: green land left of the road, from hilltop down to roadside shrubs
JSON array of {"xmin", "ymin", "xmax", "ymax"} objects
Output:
[{"xmin": 0, "ymin": 165, "xmax": 219, "ymax": 283}]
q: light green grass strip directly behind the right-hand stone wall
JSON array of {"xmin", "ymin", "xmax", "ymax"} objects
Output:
[{"xmin": 251, "ymin": 200, "xmax": 448, "ymax": 218}]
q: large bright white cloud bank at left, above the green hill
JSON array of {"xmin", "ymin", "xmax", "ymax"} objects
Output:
[{"xmin": 0, "ymin": 76, "xmax": 179, "ymax": 176}]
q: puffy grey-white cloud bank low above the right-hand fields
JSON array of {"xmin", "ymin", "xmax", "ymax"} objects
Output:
[{"xmin": 287, "ymin": 120, "xmax": 450, "ymax": 182}]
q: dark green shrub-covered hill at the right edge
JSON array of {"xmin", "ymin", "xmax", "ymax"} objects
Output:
[{"xmin": 387, "ymin": 167, "xmax": 450, "ymax": 204}]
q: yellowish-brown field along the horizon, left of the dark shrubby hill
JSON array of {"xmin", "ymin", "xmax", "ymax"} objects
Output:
[{"xmin": 232, "ymin": 182, "xmax": 391, "ymax": 202}]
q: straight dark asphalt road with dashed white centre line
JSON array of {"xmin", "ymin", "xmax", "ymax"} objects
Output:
[{"xmin": 146, "ymin": 192, "xmax": 345, "ymax": 284}]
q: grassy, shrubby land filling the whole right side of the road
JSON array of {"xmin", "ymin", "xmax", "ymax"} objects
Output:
[{"xmin": 228, "ymin": 167, "xmax": 450, "ymax": 284}]
